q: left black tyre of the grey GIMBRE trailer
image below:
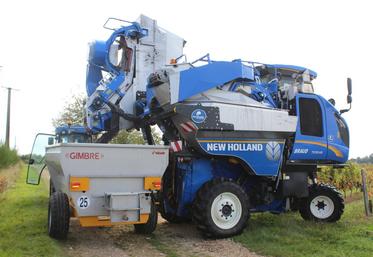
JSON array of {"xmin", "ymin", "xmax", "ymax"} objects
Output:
[{"xmin": 48, "ymin": 192, "xmax": 70, "ymax": 239}]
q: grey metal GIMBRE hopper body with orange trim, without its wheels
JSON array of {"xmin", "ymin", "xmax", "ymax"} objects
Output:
[{"xmin": 28, "ymin": 137, "xmax": 168, "ymax": 229}]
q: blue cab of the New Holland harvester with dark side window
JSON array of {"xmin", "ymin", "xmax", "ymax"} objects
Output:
[{"xmin": 290, "ymin": 93, "xmax": 349, "ymax": 164}]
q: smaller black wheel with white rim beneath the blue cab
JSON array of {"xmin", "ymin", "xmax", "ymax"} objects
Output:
[{"xmin": 299, "ymin": 184, "xmax": 345, "ymax": 222}]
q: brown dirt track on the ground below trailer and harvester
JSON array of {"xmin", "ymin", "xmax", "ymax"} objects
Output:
[{"xmin": 64, "ymin": 216, "xmax": 259, "ymax": 257}]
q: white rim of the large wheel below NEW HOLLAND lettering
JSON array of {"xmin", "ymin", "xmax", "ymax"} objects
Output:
[{"xmin": 211, "ymin": 192, "xmax": 242, "ymax": 229}]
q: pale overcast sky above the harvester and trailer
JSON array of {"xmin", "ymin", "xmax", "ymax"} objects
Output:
[{"xmin": 0, "ymin": 0, "xmax": 373, "ymax": 157}]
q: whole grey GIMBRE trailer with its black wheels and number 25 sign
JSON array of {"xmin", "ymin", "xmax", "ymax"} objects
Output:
[{"xmin": 27, "ymin": 134, "xmax": 168, "ymax": 239}]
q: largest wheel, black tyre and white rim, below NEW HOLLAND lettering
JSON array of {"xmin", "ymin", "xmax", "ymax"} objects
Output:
[{"xmin": 193, "ymin": 178, "xmax": 250, "ymax": 238}]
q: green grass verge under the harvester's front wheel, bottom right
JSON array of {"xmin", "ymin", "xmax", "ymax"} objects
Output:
[{"xmin": 234, "ymin": 200, "xmax": 373, "ymax": 257}]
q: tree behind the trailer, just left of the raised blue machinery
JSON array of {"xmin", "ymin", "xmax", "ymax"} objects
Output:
[{"xmin": 52, "ymin": 94, "xmax": 86, "ymax": 128}]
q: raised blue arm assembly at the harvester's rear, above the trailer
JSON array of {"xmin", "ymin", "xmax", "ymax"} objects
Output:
[{"xmin": 86, "ymin": 18, "xmax": 148, "ymax": 132}]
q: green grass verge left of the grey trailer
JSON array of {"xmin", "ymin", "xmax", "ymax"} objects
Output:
[{"xmin": 0, "ymin": 166, "xmax": 64, "ymax": 257}]
